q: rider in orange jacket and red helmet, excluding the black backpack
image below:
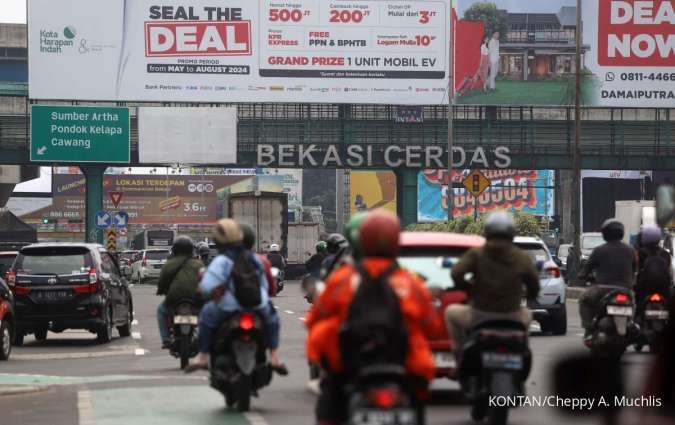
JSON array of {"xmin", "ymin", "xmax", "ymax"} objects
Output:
[{"xmin": 306, "ymin": 210, "xmax": 442, "ymax": 424}]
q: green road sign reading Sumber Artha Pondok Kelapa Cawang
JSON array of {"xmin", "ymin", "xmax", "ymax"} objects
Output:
[{"xmin": 30, "ymin": 105, "xmax": 130, "ymax": 164}]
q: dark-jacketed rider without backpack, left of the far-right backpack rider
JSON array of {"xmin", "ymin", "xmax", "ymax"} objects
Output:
[{"xmin": 579, "ymin": 218, "xmax": 637, "ymax": 338}]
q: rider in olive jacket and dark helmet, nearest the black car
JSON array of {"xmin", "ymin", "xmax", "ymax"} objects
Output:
[{"xmin": 157, "ymin": 236, "xmax": 204, "ymax": 349}]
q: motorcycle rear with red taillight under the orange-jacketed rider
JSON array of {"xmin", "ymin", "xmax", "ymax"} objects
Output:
[{"xmin": 346, "ymin": 365, "xmax": 424, "ymax": 425}]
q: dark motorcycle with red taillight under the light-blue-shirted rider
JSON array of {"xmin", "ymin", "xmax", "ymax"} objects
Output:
[{"xmin": 210, "ymin": 312, "xmax": 272, "ymax": 412}]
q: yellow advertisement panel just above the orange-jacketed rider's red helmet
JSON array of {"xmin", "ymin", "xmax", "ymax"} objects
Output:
[{"xmin": 349, "ymin": 171, "xmax": 396, "ymax": 214}]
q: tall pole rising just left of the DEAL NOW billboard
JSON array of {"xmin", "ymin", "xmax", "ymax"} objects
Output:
[{"xmin": 572, "ymin": 0, "xmax": 583, "ymax": 274}]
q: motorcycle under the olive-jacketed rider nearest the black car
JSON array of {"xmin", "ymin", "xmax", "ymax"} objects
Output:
[{"xmin": 169, "ymin": 300, "xmax": 199, "ymax": 369}]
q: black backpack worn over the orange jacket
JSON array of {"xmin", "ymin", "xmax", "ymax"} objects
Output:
[{"xmin": 339, "ymin": 263, "xmax": 408, "ymax": 375}]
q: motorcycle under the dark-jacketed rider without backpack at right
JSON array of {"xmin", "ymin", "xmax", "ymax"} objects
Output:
[{"xmin": 584, "ymin": 287, "xmax": 639, "ymax": 356}]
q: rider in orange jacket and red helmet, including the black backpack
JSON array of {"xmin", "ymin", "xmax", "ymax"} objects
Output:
[{"xmin": 306, "ymin": 210, "xmax": 443, "ymax": 424}]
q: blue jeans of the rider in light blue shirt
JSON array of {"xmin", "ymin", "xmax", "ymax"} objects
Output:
[{"xmin": 199, "ymin": 301, "xmax": 281, "ymax": 354}]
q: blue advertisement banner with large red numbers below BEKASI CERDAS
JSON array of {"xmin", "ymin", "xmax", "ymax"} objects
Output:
[{"xmin": 417, "ymin": 170, "xmax": 555, "ymax": 222}]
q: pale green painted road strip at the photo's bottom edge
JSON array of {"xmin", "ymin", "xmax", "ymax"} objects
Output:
[{"xmin": 87, "ymin": 384, "xmax": 249, "ymax": 425}]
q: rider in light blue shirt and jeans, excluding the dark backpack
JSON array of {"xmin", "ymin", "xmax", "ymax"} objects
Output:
[{"xmin": 185, "ymin": 218, "xmax": 288, "ymax": 375}]
